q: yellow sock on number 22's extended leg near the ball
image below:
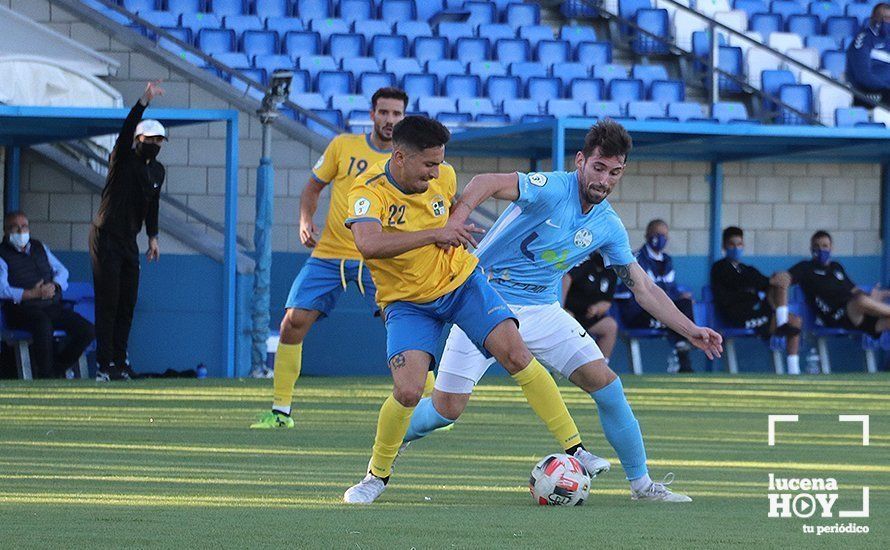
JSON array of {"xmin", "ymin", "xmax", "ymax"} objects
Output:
[{"xmin": 513, "ymin": 358, "xmax": 581, "ymax": 449}]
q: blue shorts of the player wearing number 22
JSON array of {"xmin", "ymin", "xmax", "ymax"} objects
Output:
[{"xmin": 385, "ymin": 269, "xmax": 519, "ymax": 362}]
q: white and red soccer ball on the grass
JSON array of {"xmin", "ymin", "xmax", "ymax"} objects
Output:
[{"xmin": 528, "ymin": 453, "xmax": 590, "ymax": 506}]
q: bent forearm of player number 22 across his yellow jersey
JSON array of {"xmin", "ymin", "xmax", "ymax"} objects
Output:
[{"xmin": 350, "ymin": 220, "xmax": 484, "ymax": 260}]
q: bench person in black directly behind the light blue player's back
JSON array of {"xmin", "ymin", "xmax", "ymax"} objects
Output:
[{"xmin": 562, "ymin": 252, "xmax": 618, "ymax": 363}]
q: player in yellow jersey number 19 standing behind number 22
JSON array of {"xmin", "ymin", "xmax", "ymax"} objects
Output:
[{"xmin": 251, "ymin": 88, "xmax": 432, "ymax": 428}]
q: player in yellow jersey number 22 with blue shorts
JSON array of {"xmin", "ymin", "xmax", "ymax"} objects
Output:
[{"xmin": 343, "ymin": 116, "xmax": 601, "ymax": 504}]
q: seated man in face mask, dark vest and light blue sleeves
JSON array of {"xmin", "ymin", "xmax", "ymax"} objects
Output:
[{"xmin": 0, "ymin": 212, "xmax": 95, "ymax": 378}]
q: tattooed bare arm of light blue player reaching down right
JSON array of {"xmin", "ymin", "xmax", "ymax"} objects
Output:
[{"xmin": 612, "ymin": 262, "xmax": 723, "ymax": 359}]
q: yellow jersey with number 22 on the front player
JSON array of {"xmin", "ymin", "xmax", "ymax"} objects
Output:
[{"xmin": 345, "ymin": 160, "xmax": 479, "ymax": 309}]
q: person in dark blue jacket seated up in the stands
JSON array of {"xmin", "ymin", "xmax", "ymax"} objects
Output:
[{"xmin": 847, "ymin": 3, "xmax": 890, "ymax": 107}]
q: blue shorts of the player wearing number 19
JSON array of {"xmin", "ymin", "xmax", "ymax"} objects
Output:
[{"xmin": 285, "ymin": 257, "xmax": 378, "ymax": 317}]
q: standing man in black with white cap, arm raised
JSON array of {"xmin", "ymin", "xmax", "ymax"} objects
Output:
[{"xmin": 90, "ymin": 82, "xmax": 166, "ymax": 380}]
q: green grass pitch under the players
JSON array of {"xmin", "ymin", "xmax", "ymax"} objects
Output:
[{"xmin": 0, "ymin": 374, "xmax": 890, "ymax": 550}]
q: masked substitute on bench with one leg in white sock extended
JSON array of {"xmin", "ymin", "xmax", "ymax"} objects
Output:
[{"xmin": 711, "ymin": 227, "xmax": 801, "ymax": 374}]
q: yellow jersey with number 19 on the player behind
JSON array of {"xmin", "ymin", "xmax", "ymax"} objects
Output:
[{"xmin": 312, "ymin": 134, "xmax": 391, "ymax": 260}]
